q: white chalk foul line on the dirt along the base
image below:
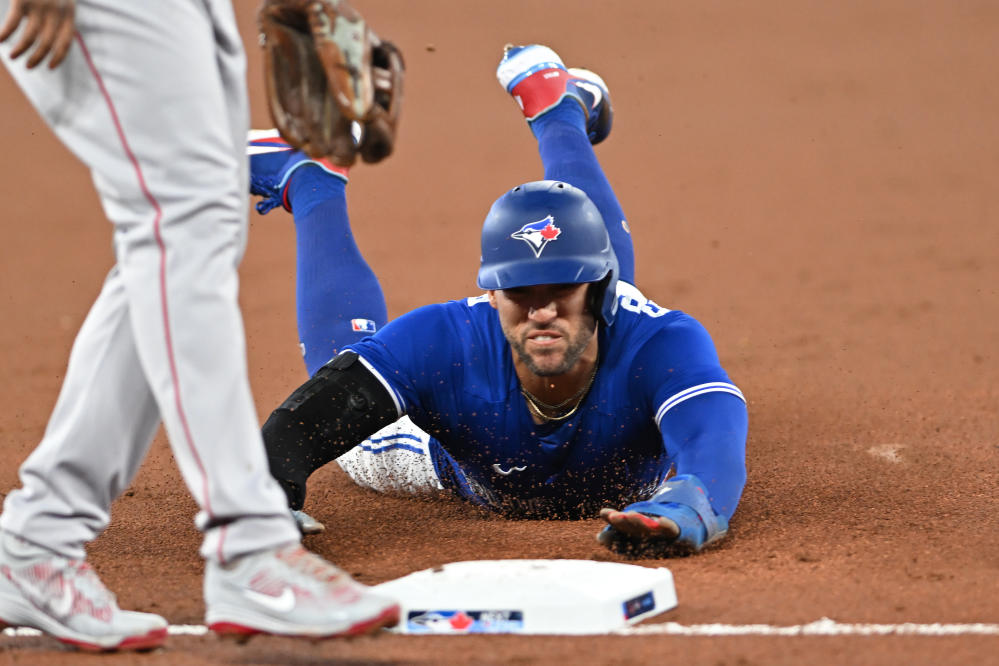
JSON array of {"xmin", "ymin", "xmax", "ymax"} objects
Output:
[{"xmin": 3, "ymin": 617, "xmax": 999, "ymax": 638}]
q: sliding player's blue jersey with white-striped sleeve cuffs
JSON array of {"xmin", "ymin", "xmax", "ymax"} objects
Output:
[{"xmin": 350, "ymin": 285, "xmax": 745, "ymax": 518}]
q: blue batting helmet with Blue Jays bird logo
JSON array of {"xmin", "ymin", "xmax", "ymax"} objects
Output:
[{"xmin": 478, "ymin": 180, "xmax": 618, "ymax": 325}]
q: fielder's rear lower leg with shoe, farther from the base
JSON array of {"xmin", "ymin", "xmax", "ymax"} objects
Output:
[{"xmin": 0, "ymin": 269, "xmax": 167, "ymax": 650}]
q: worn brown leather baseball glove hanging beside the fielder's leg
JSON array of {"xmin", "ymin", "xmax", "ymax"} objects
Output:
[{"xmin": 257, "ymin": 0, "xmax": 405, "ymax": 166}]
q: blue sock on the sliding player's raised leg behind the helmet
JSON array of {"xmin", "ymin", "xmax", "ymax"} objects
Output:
[{"xmin": 531, "ymin": 99, "xmax": 635, "ymax": 284}]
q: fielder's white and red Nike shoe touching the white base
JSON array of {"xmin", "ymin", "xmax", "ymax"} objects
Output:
[{"xmin": 205, "ymin": 543, "xmax": 399, "ymax": 639}]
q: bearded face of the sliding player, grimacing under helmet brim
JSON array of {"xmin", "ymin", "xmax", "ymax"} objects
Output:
[{"xmin": 489, "ymin": 284, "xmax": 597, "ymax": 377}]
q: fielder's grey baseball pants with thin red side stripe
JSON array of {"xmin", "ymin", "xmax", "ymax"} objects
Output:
[{"xmin": 3, "ymin": 0, "xmax": 297, "ymax": 559}]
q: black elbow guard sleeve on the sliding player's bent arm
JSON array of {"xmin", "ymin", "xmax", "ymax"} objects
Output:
[{"xmin": 263, "ymin": 351, "xmax": 399, "ymax": 509}]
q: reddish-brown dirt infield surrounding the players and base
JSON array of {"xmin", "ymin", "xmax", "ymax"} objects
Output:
[{"xmin": 0, "ymin": 0, "xmax": 999, "ymax": 666}]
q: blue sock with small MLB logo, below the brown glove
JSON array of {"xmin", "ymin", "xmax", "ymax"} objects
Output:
[{"xmin": 288, "ymin": 166, "xmax": 388, "ymax": 377}]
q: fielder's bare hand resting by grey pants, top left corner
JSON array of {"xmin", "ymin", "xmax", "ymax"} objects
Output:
[{"xmin": 0, "ymin": 0, "xmax": 76, "ymax": 69}]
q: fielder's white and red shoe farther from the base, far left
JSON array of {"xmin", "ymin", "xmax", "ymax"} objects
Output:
[{"xmin": 0, "ymin": 533, "xmax": 167, "ymax": 651}]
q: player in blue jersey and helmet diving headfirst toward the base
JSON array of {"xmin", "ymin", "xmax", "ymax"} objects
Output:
[{"xmin": 250, "ymin": 45, "xmax": 748, "ymax": 556}]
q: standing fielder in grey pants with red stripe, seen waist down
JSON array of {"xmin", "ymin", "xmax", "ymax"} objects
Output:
[{"xmin": 0, "ymin": 0, "xmax": 398, "ymax": 650}]
